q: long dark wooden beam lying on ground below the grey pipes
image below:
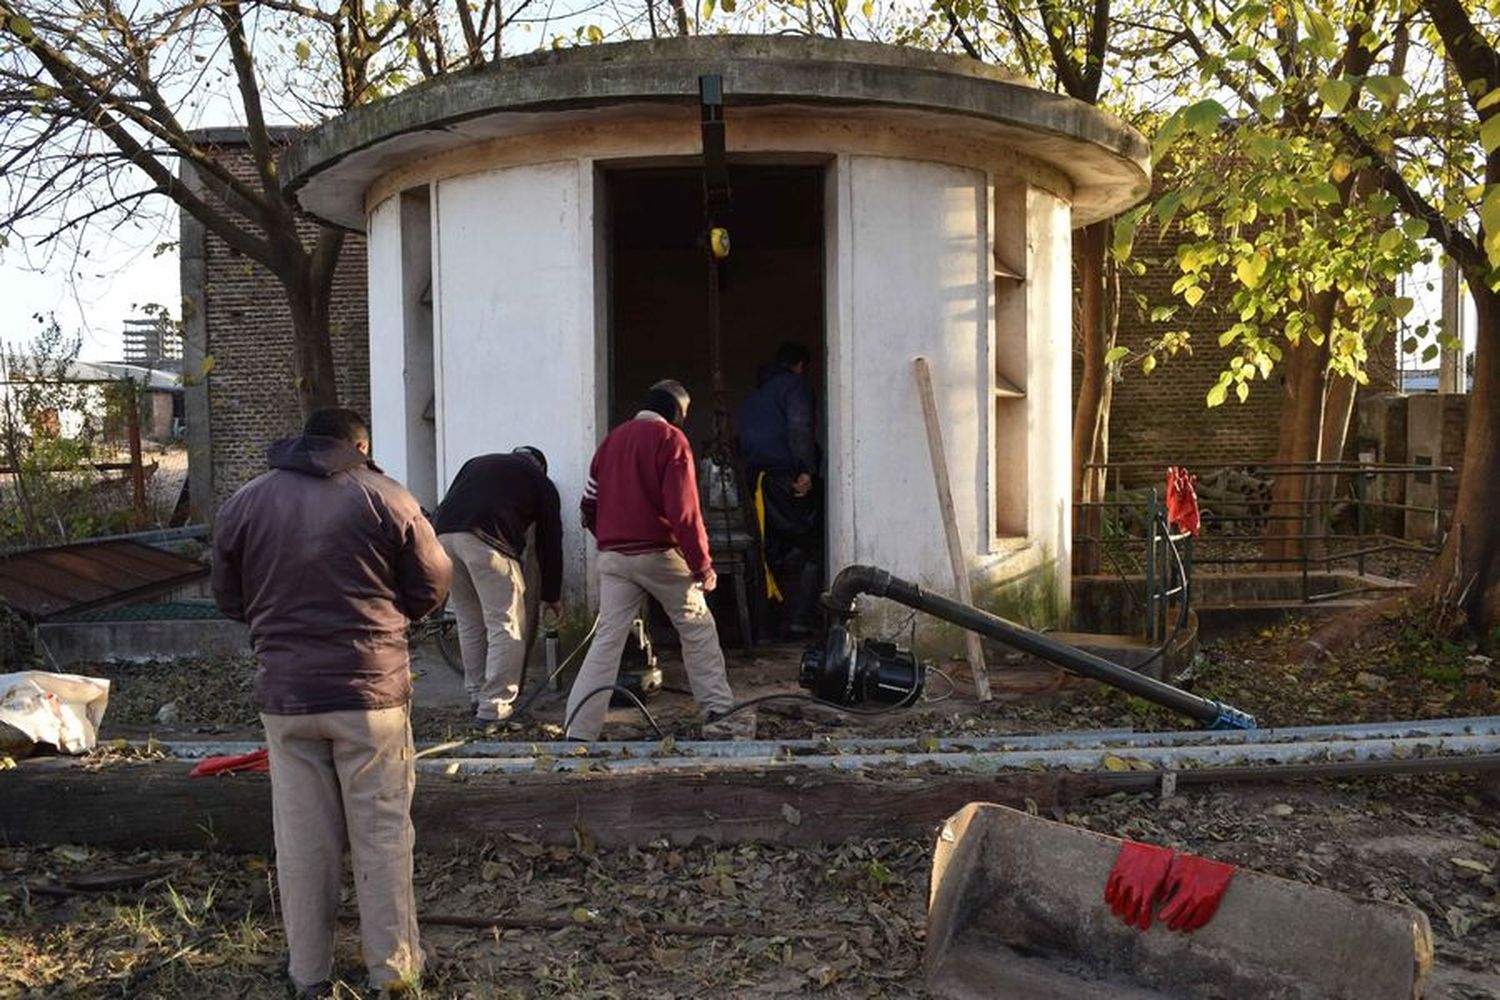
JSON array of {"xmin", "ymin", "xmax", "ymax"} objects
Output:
[{"xmin": 0, "ymin": 760, "xmax": 1106, "ymax": 852}]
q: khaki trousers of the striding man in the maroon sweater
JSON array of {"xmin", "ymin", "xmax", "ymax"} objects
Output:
[{"xmin": 563, "ymin": 549, "xmax": 735, "ymax": 739}]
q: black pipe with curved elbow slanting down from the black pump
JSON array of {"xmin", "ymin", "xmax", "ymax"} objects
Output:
[{"xmin": 824, "ymin": 565, "xmax": 1256, "ymax": 729}]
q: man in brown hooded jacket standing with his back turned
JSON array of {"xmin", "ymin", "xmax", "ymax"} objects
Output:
[{"xmin": 213, "ymin": 409, "xmax": 452, "ymax": 997}]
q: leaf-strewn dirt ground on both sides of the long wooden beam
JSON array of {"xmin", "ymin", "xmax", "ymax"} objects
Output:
[{"xmin": 11, "ymin": 605, "xmax": 1500, "ymax": 1000}]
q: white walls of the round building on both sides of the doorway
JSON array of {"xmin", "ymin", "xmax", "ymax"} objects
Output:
[{"xmin": 371, "ymin": 140, "xmax": 1071, "ymax": 626}]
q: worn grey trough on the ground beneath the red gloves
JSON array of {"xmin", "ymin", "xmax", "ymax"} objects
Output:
[{"xmin": 924, "ymin": 802, "xmax": 1433, "ymax": 1000}]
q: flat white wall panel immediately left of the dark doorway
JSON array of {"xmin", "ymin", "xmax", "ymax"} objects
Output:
[{"xmin": 432, "ymin": 160, "xmax": 605, "ymax": 597}]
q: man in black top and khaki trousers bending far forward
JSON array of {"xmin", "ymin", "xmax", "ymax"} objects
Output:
[{"xmin": 432, "ymin": 445, "xmax": 563, "ymax": 727}]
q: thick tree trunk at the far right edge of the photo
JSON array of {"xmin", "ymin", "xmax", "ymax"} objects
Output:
[{"xmin": 1418, "ymin": 281, "xmax": 1500, "ymax": 636}]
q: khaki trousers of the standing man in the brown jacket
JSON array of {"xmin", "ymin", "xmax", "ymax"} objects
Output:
[{"xmin": 261, "ymin": 705, "xmax": 422, "ymax": 988}]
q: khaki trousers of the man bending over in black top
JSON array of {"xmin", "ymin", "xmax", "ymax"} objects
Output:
[{"xmin": 438, "ymin": 531, "xmax": 527, "ymax": 721}]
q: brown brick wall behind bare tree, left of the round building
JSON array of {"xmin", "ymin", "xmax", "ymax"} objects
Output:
[{"xmin": 183, "ymin": 135, "xmax": 369, "ymax": 514}]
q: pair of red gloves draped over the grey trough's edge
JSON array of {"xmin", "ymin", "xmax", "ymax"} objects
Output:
[{"xmin": 1104, "ymin": 840, "xmax": 1235, "ymax": 934}]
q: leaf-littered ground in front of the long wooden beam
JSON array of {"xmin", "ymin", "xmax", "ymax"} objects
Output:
[{"xmin": 0, "ymin": 778, "xmax": 1500, "ymax": 1000}]
